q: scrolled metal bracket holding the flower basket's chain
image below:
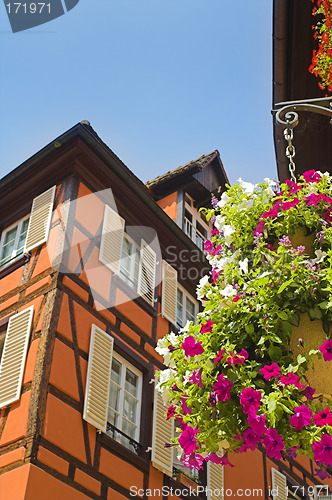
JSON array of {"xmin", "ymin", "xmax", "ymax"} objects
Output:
[{"xmin": 271, "ymin": 97, "xmax": 332, "ymax": 129}]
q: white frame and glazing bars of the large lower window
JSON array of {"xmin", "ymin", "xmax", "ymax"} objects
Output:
[{"xmin": 106, "ymin": 351, "xmax": 143, "ymax": 446}]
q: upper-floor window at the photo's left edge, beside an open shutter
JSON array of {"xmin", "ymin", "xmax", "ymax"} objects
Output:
[{"xmin": 0, "ymin": 216, "xmax": 29, "ymax": 267}]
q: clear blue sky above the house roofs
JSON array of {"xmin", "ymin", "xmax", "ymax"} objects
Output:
[{"xmin": 0, "ymin": 0, "xmax": 276, "ymax": 187}]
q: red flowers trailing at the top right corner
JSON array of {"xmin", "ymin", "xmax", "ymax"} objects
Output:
[{"xmin": 309, "ymin": 0, "xmax": 332, "ymax": 92}]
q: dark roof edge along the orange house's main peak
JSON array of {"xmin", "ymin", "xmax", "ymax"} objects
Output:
[{"xmin": 0, "ymin": 123, "xmax": 208, "ymax": 267}]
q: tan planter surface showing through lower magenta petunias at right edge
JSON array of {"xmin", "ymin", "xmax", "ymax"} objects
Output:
[{"xmin": 289, "ymin": 313, "xmax": 332, "ymax": 397}]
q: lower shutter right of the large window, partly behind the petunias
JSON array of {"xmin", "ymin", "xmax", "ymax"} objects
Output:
[{"xmin": 151, "ymin": 389, "xmax": 174, "ymax": 477}]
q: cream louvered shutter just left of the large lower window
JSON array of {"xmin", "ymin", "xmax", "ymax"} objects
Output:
[{"xmin": 83, "ymin": 325, "xmax": 113, "ymax": 432}]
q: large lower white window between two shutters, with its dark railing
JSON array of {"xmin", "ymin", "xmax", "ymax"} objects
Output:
[{"xmin": 107, "ymin": 353, "xmax": 142, "ymax": 450}]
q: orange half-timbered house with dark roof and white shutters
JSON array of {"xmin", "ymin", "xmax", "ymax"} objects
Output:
[{"xmin": 0, "ymin": 122, "xmax": 325, "ymax": 500}]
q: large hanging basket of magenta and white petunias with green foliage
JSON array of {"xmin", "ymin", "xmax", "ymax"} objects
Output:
[{"xmin": 157, "ymin": 170, "xmax": 332, "ymax": 478}]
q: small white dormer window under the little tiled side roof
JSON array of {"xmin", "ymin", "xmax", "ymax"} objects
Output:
[{"xmin": 184, "ymin": 193, "xmax": 209, "ymax": 250}]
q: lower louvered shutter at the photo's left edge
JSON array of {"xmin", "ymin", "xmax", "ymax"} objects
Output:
[{"xmin": 0, "ymin": 306, "xmax": 33, "ymax": 408}]
